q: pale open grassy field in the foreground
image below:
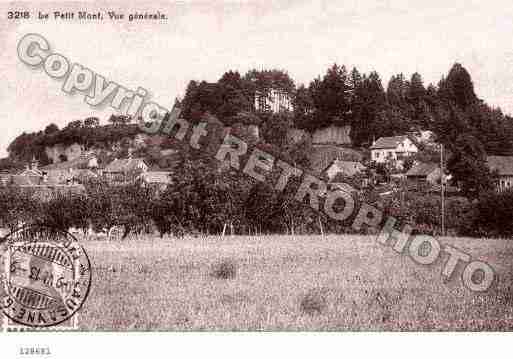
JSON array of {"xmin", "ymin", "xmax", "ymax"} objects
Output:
[{"xmin": 80, "ymin": 236, "xmax": 513, "ymax": 330}]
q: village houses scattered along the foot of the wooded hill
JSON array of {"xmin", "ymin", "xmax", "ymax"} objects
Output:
[{"xmin": 0, "ymin": 119, "xmax": 513, "ymax": 201}]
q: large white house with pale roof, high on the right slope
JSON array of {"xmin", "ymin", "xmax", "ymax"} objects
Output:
[{"xmin": 370, "ymin": 136, "xmax": 419, "ymax": 169}]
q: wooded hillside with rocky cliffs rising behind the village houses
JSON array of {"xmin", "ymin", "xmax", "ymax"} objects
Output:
[{"xmin": 4, "ymin": 64, "xmax": 513, "ymax": 178}]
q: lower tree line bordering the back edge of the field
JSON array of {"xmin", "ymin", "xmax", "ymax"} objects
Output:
[{"xmin": 0, "ymin": 150, "xmax": 513, "ymax": 238}]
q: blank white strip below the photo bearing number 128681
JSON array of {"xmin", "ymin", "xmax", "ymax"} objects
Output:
[{"xmin": 0, "ymin": 332, "xmax": 513, "ymax": 359}]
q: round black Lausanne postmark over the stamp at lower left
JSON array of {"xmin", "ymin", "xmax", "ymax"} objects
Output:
[{"xmin": 0, "ymin": 226, "xmax": 91, "ymax": 327}]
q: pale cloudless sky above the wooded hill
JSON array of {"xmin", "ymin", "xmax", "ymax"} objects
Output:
[{"xmin": 0, "ymin": 0, "xmax": 513, "ymax": 157}]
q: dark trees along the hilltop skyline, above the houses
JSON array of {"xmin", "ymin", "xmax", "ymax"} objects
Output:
[{"xmin": 4, "ymin": 64, "xmax": 513, "ymax": 198}]
